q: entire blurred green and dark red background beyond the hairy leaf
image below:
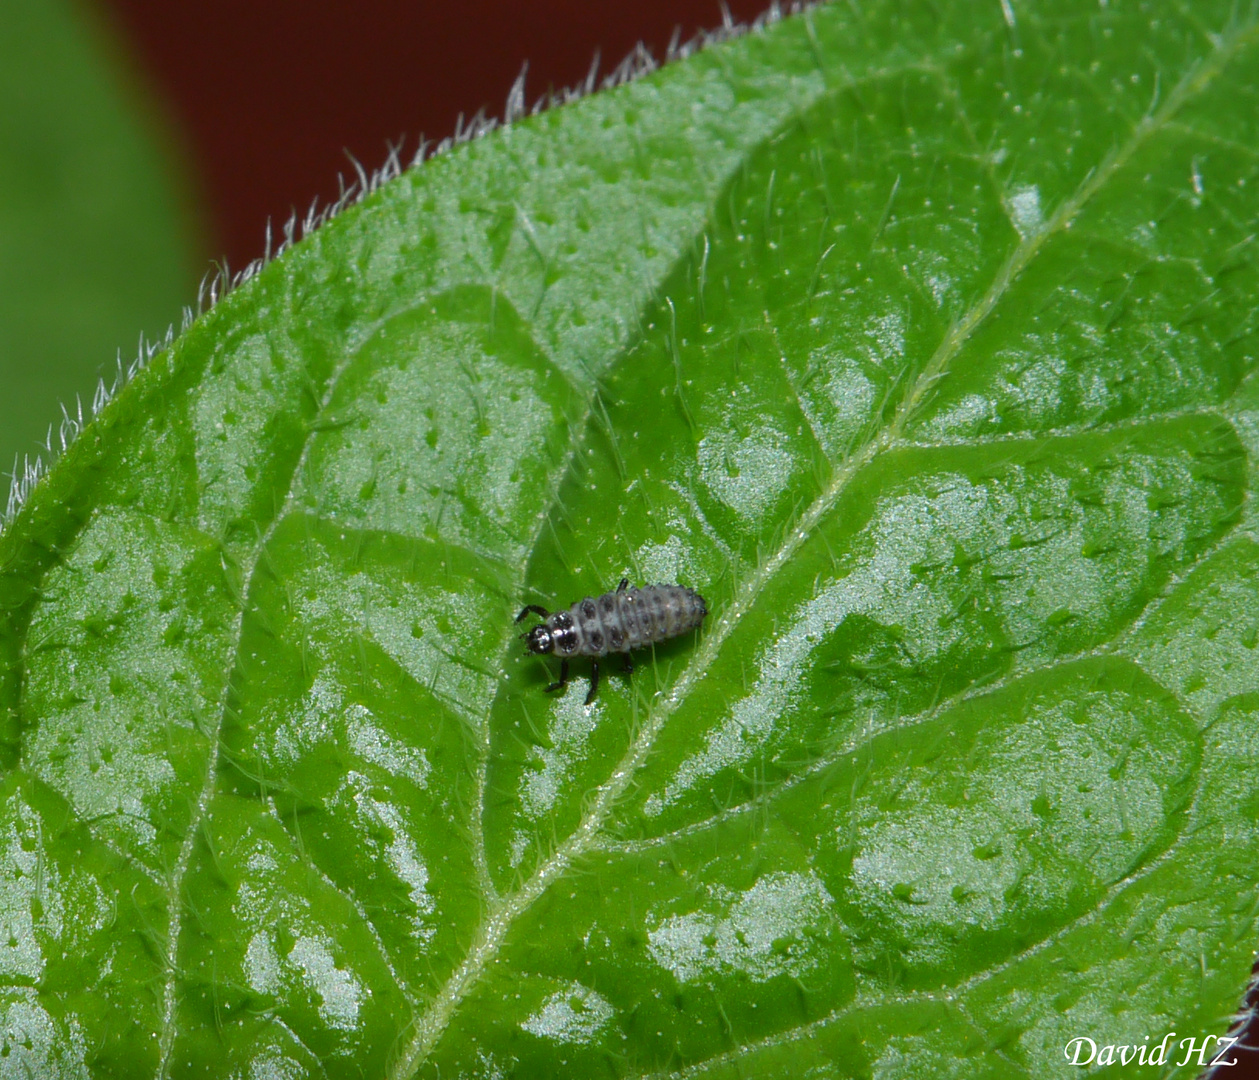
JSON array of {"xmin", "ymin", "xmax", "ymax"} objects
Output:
[{"xmin": 0, "ymin": 0, "xmax": 768, "ymax": 472}]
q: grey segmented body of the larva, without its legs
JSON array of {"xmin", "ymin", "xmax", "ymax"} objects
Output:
[{"xmin": 546, "ymin": 585, "xmax": 708, "ymax": 656}]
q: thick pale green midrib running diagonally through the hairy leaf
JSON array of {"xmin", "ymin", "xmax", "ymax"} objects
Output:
[{"xmin": 390, "ymin": 25, "xmax": 1255, "ymax": 1080}]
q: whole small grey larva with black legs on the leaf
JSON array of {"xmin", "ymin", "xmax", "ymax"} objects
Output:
[{"xmin": 516, "ymin": 578, "xmax": 708, "ymax": 705}]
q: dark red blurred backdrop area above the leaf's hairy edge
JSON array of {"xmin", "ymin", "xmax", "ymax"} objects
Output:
[{"xmin": 96, "ymin": 0, "xmax": 768, "ymax": 269}]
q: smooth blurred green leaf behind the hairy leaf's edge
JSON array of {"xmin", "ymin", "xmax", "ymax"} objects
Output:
[{"xmin": 0, "ymin": 0, "xmax": 199, "ymax": 472}]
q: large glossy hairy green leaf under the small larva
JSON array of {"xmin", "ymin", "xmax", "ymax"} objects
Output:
[{"xmin": 0, "ymin": 4, "xmax": 1259, "ymax": 1077}]
